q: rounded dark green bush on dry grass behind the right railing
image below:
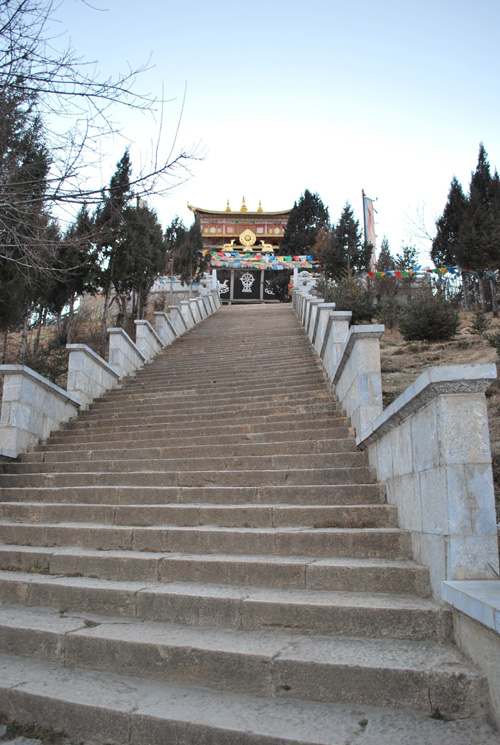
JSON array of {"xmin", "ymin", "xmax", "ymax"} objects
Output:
[{"xmin": 398, "ymin": 295, "xmax": 460, "ymax": 341}]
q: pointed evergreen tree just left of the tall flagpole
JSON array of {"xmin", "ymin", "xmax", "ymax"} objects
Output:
[{"xmin": 319, "ymin": 202, "xmax": 372, "ymax": 280}]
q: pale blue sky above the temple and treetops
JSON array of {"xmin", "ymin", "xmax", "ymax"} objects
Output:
[{"xmin": 52, "ymin": 0, "xmax": 500, "ymax": 261}]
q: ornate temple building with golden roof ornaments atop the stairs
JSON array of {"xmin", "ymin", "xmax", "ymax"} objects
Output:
[{"xmin": 188, "ymin": 197, "xmax": 320, "ymax": 303}]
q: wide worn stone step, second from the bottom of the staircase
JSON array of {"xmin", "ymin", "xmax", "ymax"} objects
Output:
[{"xmin": 0, "ymin": 606, "xmax": 488, "ymax": 718}]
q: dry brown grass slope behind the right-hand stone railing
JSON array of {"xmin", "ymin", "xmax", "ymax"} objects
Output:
[{"xmin": 380, "ymin": 313, "xmax": 500, "ymax": 522}]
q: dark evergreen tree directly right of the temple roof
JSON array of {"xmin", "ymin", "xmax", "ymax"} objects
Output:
[{"xmin": 280, "ymin": 189, "xmax": 330, "ymax": 255}]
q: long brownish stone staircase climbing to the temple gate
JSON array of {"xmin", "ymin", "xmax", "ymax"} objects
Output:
[{"xmin": 0, "ymin": 306, "xmax": 500, "ymax": 745}]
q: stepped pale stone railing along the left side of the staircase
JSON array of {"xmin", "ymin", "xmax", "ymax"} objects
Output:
[{"xmin": 0, "ymin": 291, "xmax": 221, "ymax": 459}]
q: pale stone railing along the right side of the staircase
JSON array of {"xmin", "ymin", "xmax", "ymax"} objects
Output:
[{"xmin": 293, "ymin": 289, "xmax": 500, "ymax": 722}]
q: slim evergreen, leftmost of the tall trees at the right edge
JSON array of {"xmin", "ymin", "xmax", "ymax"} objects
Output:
[{"xmin": 431, "ymin": 176, "xmax": 467, "ymax": 267}]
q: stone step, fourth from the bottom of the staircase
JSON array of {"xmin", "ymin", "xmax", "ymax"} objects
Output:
[{"xmin": 0, "ymin": 544, "xmax": 430, "ymax": 597}]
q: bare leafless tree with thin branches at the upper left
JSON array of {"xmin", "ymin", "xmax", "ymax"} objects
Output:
[{"xmin": 0, "ymin": 0, "xmax": 199, "ymax": 271}]
